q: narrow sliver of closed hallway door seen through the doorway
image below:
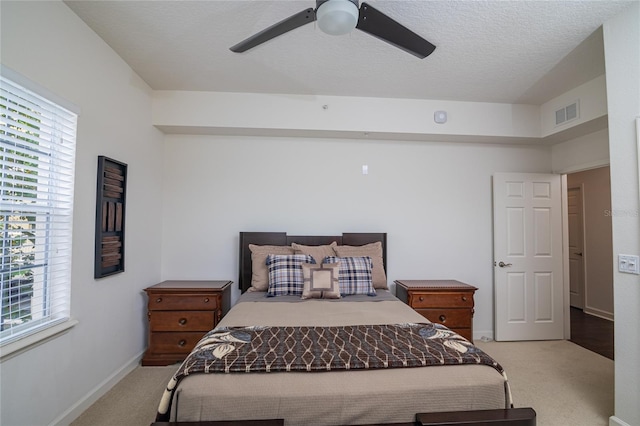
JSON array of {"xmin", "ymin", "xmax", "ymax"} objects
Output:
[{"xmin": 567, "ymin": 187, "xmax": 584, "ymax": 309}]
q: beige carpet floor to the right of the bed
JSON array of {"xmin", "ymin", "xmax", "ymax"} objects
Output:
[{"xmin": 476, "ymin": 340, "xmax": 614, "ymax": 426}]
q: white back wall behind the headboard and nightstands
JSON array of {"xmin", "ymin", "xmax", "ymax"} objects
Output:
[{"xmin": 162, "ymin": 135, "xmax": 551, "ymax": 337}]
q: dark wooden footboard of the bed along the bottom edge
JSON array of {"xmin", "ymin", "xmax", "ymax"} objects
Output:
[{"xmin": 151, "ymin": 408, "xmax": 536, "ymax": 426}]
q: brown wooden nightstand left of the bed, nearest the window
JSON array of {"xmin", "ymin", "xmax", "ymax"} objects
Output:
[{"xmin": 142, "ymin": 281, "xmax": 231, "ymax": 365}]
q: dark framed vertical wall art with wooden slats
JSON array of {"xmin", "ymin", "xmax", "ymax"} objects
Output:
[{"xmin": 94, "ymin": 155, "xmax": 127, "ymax": 278}]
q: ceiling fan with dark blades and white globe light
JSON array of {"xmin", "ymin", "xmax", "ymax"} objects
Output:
[{"xmin": 230, "ymin": 0, "xmax": 436, "ymax": 59}]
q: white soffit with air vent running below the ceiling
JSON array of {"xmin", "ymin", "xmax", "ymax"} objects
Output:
[{"xmin": 152, "ymin": 73, "xmax": 607, "ymax": 145}]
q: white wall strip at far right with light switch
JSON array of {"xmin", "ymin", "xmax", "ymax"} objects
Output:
[{"xmin": 603, "ymin": 2, "xmax": 640, "ymax": 425}]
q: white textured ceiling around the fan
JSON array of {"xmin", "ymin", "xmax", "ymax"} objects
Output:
[{"xmin": 66, "ymin": 0, "xmax": 633, "ymax": 104}]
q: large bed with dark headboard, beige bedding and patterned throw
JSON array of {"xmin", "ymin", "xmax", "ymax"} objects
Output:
[{"xmin": 152, "ymin": 232, "xmax": 535, "ymax": 425}]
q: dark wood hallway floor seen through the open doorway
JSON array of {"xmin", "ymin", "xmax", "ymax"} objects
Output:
[{"xmin": 571, "ymin": 307, "xmax": 614, "ymax": 359}]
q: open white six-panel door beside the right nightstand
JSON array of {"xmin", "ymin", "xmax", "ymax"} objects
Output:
[{"xmin": 493, "ymin": 173, "xmax": 564, "ymax": 340}]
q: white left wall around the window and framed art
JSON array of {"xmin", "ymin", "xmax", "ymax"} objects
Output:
[{"xmin": 0, "ymin": 1, "xmax": 162, "ymax": 426}]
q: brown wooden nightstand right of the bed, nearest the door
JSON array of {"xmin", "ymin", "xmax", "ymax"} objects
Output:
[{"xmin": 395, "ymin": 280, "xmax": 477, "ymax": 341}]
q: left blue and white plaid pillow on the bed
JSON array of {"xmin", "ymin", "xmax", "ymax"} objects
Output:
[{"xmin": 267, "ymin": 254, "xmax": 315, "ymax": 297}]
